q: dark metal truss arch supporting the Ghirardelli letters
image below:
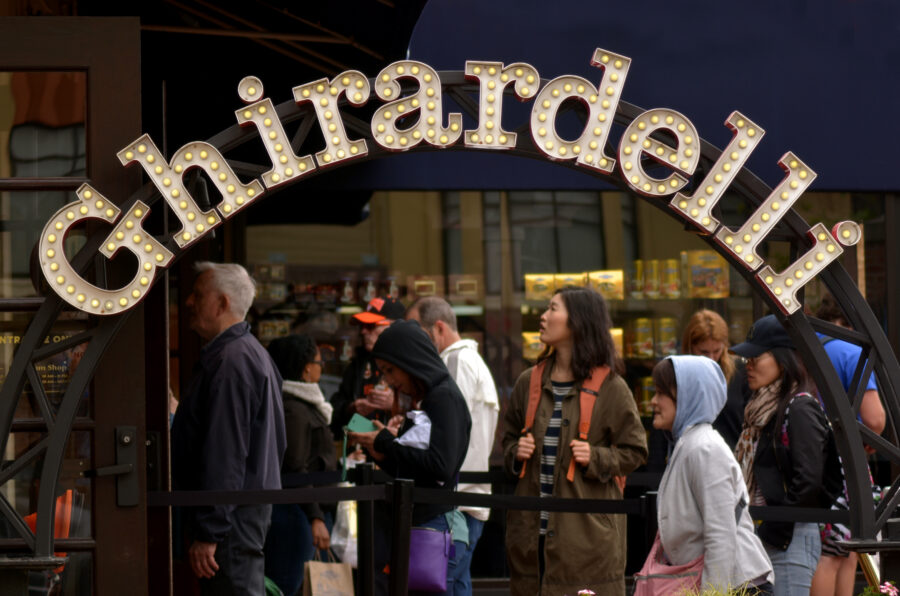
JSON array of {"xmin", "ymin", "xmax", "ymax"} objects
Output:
[{"xmin": 0, "ymin": 71, "xmax": 900, "ymax": 566}]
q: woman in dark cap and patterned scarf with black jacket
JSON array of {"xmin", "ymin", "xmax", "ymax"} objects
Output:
[{"xmin": 731, "ymin": 315, "xmax": 840, "ymax": 596}]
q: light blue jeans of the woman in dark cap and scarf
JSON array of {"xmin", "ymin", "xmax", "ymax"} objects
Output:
[{"xmin": 765, "ymin": 524, "xmax": 822, "ymax": 596}]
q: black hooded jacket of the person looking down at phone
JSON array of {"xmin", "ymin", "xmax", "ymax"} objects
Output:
[{"xmin": 372, "ymin": 321, "xmax": 472, "ymax": 525}]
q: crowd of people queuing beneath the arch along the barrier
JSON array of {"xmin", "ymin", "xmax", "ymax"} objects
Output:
[{"xmin": 172, "ymin": 263, "xmax": 885, "ymax": 596}]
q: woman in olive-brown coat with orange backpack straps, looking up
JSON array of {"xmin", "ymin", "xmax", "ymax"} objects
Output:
[{"xmin": 503, "ymin": 288, "xmax": 647, "ymax": 596}]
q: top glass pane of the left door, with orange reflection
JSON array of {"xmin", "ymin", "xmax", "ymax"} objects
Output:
[{"xmin": 0, "ymin": 71, "xmax": 87, "ymax": 178}]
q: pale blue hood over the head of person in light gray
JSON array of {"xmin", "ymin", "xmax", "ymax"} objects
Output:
[{"xmin": 669, "ymin": 356, "xmax": 728, "ymax": 441}]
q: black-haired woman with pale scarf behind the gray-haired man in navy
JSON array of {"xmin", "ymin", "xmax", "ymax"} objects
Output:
[{"xmin": 265, "ymin": 335, "xmax": 337, "ymax": 594}]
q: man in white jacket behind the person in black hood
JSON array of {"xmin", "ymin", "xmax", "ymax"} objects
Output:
[{"xmin": 406, "ymin": 296, "xmax": 500, "ymax": 596}]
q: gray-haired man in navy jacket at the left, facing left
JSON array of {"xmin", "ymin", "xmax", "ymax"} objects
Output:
[{"xmin": 172, "ymin": 262, "xmax": 287, "ymax": 595}]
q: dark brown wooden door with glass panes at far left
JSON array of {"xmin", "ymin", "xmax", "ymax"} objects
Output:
[{"xmin": 0, "ymin": 17, "xmax": 149, "ymax": 595}]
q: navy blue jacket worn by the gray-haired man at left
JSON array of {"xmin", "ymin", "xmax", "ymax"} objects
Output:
[{"xmin": 172, "ymin": 322, "xmax": 287, "ymax": 542}]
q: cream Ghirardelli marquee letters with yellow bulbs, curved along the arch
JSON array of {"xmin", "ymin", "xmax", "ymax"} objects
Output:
[{"xmin": 40, "ymin": 49, "xmax": 861, "ymax": 315}]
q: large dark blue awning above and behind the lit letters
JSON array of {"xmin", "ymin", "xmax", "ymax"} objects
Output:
[{"xmin": 329, "ymin": 0, "xmax": 900, "ymax": 191}]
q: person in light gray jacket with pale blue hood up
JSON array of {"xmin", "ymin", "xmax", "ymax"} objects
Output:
[{"xmin": 650, "ymin": 356, "xmax": 772, "ymax": 594}]
